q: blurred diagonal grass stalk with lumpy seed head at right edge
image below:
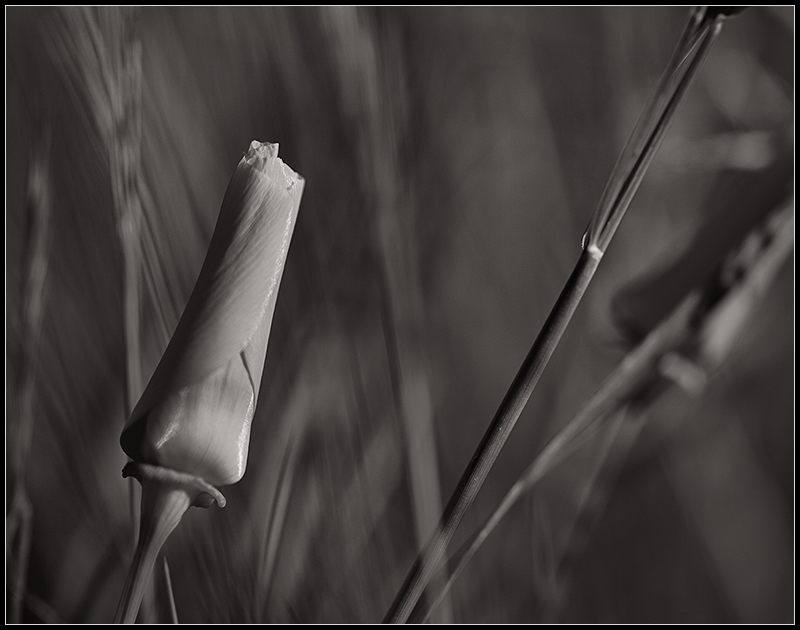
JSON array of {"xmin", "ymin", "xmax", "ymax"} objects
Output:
[{"xmin": 423, "ymin": 200, "xmax": 794, "ymax": 622}]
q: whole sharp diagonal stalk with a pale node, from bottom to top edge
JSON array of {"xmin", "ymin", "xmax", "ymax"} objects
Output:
[{"xmin": 384, "ymin": 10, "xmax": 726, "ymax": 623}]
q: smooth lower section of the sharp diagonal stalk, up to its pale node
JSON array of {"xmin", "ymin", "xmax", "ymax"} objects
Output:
[{"xmin": 384, "ymin": 248, "xmax": 602, "ymax": 623}]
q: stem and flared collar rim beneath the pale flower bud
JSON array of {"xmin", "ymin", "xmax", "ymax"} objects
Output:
[{"xmin": 114, "ymin": 462, "xmax": 225, "ymax": 623}]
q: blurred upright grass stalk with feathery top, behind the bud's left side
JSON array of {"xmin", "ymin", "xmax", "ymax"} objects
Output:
[{"xmin": 47, "ymin": 7, "xmax": 149, "ymax": 618}]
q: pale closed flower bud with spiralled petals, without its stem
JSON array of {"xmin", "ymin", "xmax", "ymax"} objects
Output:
[{"xmin": 120, "ymin": 140, "xmax": 305, "ymax": 485}]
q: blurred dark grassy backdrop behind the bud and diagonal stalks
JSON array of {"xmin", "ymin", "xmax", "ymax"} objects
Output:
[{"xmin": 6, "ymin": 7, "xmax": 794, "ymax": 623}]
